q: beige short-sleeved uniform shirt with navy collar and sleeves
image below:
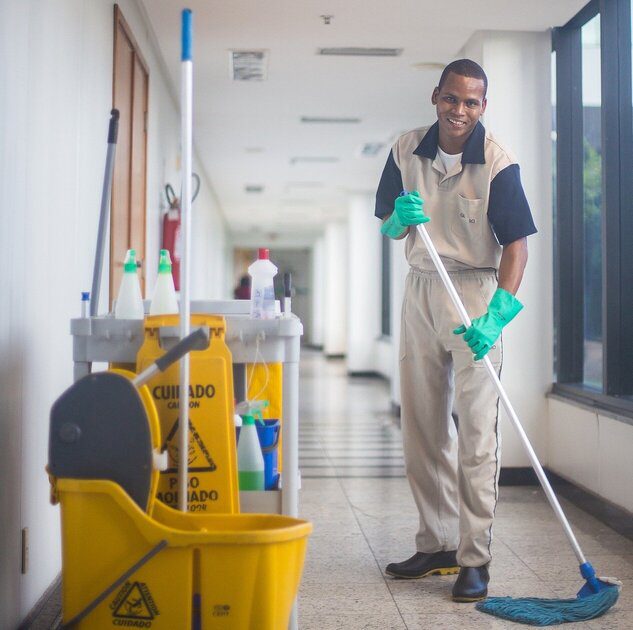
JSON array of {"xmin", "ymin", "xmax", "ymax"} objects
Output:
[{"xmin": 376, "ymin": 123, "xmax": 536, "ymax": 271}]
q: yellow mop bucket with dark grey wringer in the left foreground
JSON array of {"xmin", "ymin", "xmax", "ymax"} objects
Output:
[{"xmin": 48, "ymin": 330, "xmax": 312, "ymax": 630}]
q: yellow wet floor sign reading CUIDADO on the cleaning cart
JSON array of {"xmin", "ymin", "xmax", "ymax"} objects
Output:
[{"xmin": 136, "ymin": 315, "xmax": 239, "ymax": 513}]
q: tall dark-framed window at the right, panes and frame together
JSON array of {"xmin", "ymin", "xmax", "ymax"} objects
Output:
[{"xmin": 552, "ymin": 0, "xmax": 633, "ymax": 417}]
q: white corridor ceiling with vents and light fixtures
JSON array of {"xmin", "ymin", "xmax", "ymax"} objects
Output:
[{"xmin": 141, "ymin": 0, "xmax": 586, "ymax": 241}]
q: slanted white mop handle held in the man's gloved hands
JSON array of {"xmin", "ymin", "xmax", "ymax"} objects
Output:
[{"xmin": 416, "ymin": 224, "xmax": 586, "ymax": 564}]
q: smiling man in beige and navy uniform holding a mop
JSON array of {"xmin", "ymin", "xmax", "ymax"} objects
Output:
[{"xmin": 376, "ymin": 59, "xmax": 536, "ymax": 601}]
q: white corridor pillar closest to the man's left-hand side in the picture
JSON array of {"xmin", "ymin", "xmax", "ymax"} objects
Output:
[{"xmin": 347, "ymin": 195, "xmax": 382, "ymax": 372}]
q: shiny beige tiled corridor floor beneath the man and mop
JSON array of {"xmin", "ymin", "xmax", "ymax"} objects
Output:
[{"xmin": 299, "ymin": 352, "xmax": 633, "ymax": 630}]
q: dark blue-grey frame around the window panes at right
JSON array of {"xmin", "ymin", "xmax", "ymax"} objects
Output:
[{"xmin": 552, "ymin": 0, "xmax": 633, "ymax": 418}]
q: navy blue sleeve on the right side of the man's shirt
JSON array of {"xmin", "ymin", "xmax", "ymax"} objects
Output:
[{"xmin": 488, "ymin": 164, "xmax": 537, "ymax": 245}]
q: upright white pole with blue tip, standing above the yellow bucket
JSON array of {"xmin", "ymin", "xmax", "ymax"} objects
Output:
[{"xmin": 178, "ymin": 9, "xmax": 193, "ymax": 512}]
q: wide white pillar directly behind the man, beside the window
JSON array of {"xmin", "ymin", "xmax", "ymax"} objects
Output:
[{"xmin": 457, "ymin": 32, "xmax": 553, "ymax": 466}]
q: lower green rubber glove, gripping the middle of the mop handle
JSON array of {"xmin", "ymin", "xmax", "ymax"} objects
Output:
[{"xmin": 453, "ymin": 289, "xmax": 523, "ymax": 361}]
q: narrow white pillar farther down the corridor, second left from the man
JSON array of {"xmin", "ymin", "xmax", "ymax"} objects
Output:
[{"xmin": 323, "ymin": 222, "xmax": 348, "ymax": 356}]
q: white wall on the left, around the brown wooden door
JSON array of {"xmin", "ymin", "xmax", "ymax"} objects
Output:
[{"xmin": 0, "ymin": 0, "xmax": 225, "ymax": 628}]
